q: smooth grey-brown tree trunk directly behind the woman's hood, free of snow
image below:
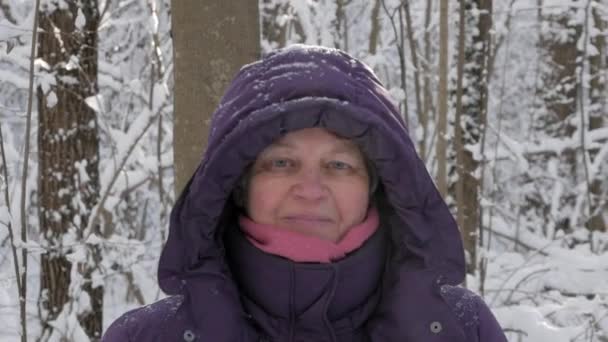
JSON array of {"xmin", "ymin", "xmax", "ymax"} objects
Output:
[{"xmin": 172, "ymin": 0, "xmax": 260, "ymax": 193}]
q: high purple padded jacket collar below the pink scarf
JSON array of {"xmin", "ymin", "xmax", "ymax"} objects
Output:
[{"xmin": 226, "ymin": 220, "xmax": 387, "ymax": 341}]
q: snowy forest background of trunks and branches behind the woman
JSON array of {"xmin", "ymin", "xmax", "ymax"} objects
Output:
[{"xmin": 0, "ymin": 0, "xmax": 608, "ymax": 342}]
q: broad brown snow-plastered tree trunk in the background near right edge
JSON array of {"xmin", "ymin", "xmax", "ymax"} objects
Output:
[{"xmin": 523, "ymin": 0, "xmax": 582, "ymax": 238}]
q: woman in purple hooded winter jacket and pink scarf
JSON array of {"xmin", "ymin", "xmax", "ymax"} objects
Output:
[{"xmin": 104, "ymin": 46, "xmax": 506, "ymax": 342}]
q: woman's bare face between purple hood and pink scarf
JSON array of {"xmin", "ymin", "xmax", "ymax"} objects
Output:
[{"xmin": 247, "ymin": 128, "xmax": 369, "ymax": 242}]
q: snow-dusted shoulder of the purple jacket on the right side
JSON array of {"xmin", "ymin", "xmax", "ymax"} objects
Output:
[{"xmin": 441, "ymin": 285, "xmax": 507, "ymax": 342}]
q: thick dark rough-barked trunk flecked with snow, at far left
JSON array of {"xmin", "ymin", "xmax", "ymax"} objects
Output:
[{"xmin": 37, "ymin": 1, "xmax": 103, "ymax": 340}]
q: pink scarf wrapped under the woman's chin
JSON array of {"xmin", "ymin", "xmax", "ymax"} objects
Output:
[{"xmin": 239, "ymin": 208, "xmax": 379, "ymax": 263}]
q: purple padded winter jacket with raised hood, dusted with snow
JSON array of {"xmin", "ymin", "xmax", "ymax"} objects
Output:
[{"xmin": 103, "ymin": 45, "xmax": 507, "ymax": 342}]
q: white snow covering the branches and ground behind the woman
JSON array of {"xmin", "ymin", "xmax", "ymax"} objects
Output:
[{"xmin": 0, "ymin": 0, "xmax": 608, "ymax": 342}]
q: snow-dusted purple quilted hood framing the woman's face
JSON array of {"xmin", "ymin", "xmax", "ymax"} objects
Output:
[{"xmin": 158, "ymin": 45, "xmax": 465, "ymax": 296}]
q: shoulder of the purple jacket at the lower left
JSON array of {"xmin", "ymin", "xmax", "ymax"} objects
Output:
[{"xmin": 102, "ymin": 296, "xmax": 188, "ymax": 342}]
